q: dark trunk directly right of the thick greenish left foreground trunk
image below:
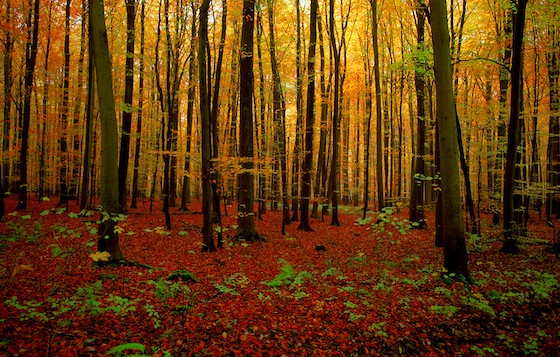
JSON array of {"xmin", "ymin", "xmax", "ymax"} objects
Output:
[{"xmin": 119, "ymin": 0, "xmax": 136, "ymax": 212}]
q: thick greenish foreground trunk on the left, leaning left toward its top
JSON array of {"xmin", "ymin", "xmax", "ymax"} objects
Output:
[{"xmin": 89, "ymin": 0, "xmax": 124, "ymax": 262}]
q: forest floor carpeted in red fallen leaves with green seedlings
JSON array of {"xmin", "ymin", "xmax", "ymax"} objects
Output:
[{"xmin": 0, "ymin": 199, "xmax": 560, "ymax": 356}]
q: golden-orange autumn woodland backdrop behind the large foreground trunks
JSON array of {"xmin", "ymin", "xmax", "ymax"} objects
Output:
[{"xmin": 2, "ymin": 0, "xmax": 559, "ymax": 231}]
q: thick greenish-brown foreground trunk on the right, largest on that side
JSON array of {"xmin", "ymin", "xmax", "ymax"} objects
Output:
[{"xmin": 430, "ymin": 0, "xmax": 469, "ymax": 278}]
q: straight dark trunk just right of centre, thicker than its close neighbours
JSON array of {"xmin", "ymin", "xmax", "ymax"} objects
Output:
[{"xmin": 298, "ymin": 0, "xmax": 318, "ymax": 231}]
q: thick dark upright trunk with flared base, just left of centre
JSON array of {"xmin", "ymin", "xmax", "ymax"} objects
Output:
[{"xmin": 236, "ymin": 0, "xmax": 262, "ymax": 241}]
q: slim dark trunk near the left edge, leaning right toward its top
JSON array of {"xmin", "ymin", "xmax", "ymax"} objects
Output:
[{"xmin": 17, "ymin": 0, "xmax": 40, "ymax": 209}]
